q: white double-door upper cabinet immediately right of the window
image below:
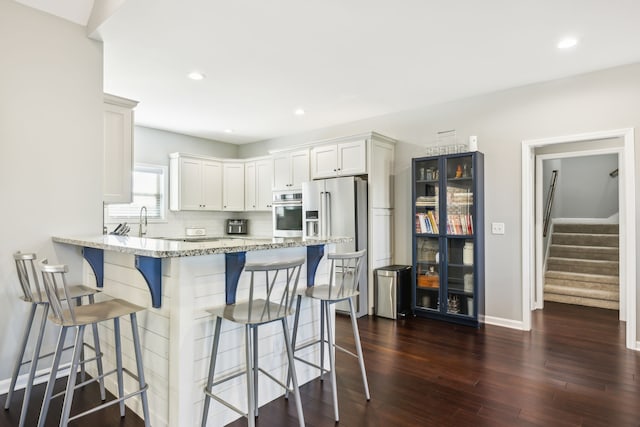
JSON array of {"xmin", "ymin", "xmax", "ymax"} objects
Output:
[{"xmin": 169, "ymin": 153, "xmax": 222, "ymax": 211}]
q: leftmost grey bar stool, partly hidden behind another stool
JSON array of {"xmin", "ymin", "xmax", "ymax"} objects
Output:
[{"xmin": 4, "ymin": 251, "xmax": 105, "ymax": 427}]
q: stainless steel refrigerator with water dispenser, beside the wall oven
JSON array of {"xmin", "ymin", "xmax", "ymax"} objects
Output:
[{"xmin": 302, "ymin": 176, "xmax": 369, "ymax": 317}]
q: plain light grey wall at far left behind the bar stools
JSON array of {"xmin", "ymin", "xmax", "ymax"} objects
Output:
[{"xmin": 0, "ymin": 0, "xmax": 102, "ymax": 386}]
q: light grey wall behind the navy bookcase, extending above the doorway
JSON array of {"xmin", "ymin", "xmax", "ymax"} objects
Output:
[{"xmin": 239, "ymin": 64, "xmax": 640, "ymax": 323}]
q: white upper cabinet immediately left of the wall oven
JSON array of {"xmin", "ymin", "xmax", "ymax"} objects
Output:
[{"xmin": 244, "ymin": 158, "xmax": 273, "ymax": 211}]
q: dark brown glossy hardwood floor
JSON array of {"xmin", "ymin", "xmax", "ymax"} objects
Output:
[{"xmin": 0, "ymin": 303, "xmax": 640, "ymax": 427}]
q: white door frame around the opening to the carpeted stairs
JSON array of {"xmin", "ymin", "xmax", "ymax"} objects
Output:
[{"xmin": 522, "ymin": 128, "xmax": 637, "ymax": 350}]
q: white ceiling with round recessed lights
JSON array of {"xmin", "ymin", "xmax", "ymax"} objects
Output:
[{"xmin": 19, "ymin": 0, "xmax": 640, "ymax": 143}]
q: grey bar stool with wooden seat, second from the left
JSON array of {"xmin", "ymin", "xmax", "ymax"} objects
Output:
[{"xmin": 38, "ymin": 259, "xmax": 150, "ymax": 427}]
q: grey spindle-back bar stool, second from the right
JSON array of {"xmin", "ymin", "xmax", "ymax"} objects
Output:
[{"xmin": 202, "ymin": 259, "xmax": 304, "ymax": 427}]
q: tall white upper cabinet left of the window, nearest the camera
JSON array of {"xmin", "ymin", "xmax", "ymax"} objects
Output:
[{"xmin": 102, "ymin": 94, "xmax": 138, "ymax": 203}]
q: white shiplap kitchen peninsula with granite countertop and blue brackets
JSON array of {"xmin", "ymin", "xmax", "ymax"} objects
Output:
[{"xmin": 53, "ymin": 235, "xmax": 351, "ymax": 426}]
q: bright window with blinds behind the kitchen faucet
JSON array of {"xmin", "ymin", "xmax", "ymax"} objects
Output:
[{"xmin": 105, "ymin": 164, "xmax": 167, "ymax": 222}]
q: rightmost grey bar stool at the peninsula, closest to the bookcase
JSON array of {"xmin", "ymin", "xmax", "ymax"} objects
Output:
[{"xmin": 287, "ymin": 250, "xmax": 371, "ymax": 422}]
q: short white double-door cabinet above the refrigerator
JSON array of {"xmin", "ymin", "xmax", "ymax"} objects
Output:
[{"xmin": 311, "ymin": 140, "xmax": 367, "ymax": 179}]
